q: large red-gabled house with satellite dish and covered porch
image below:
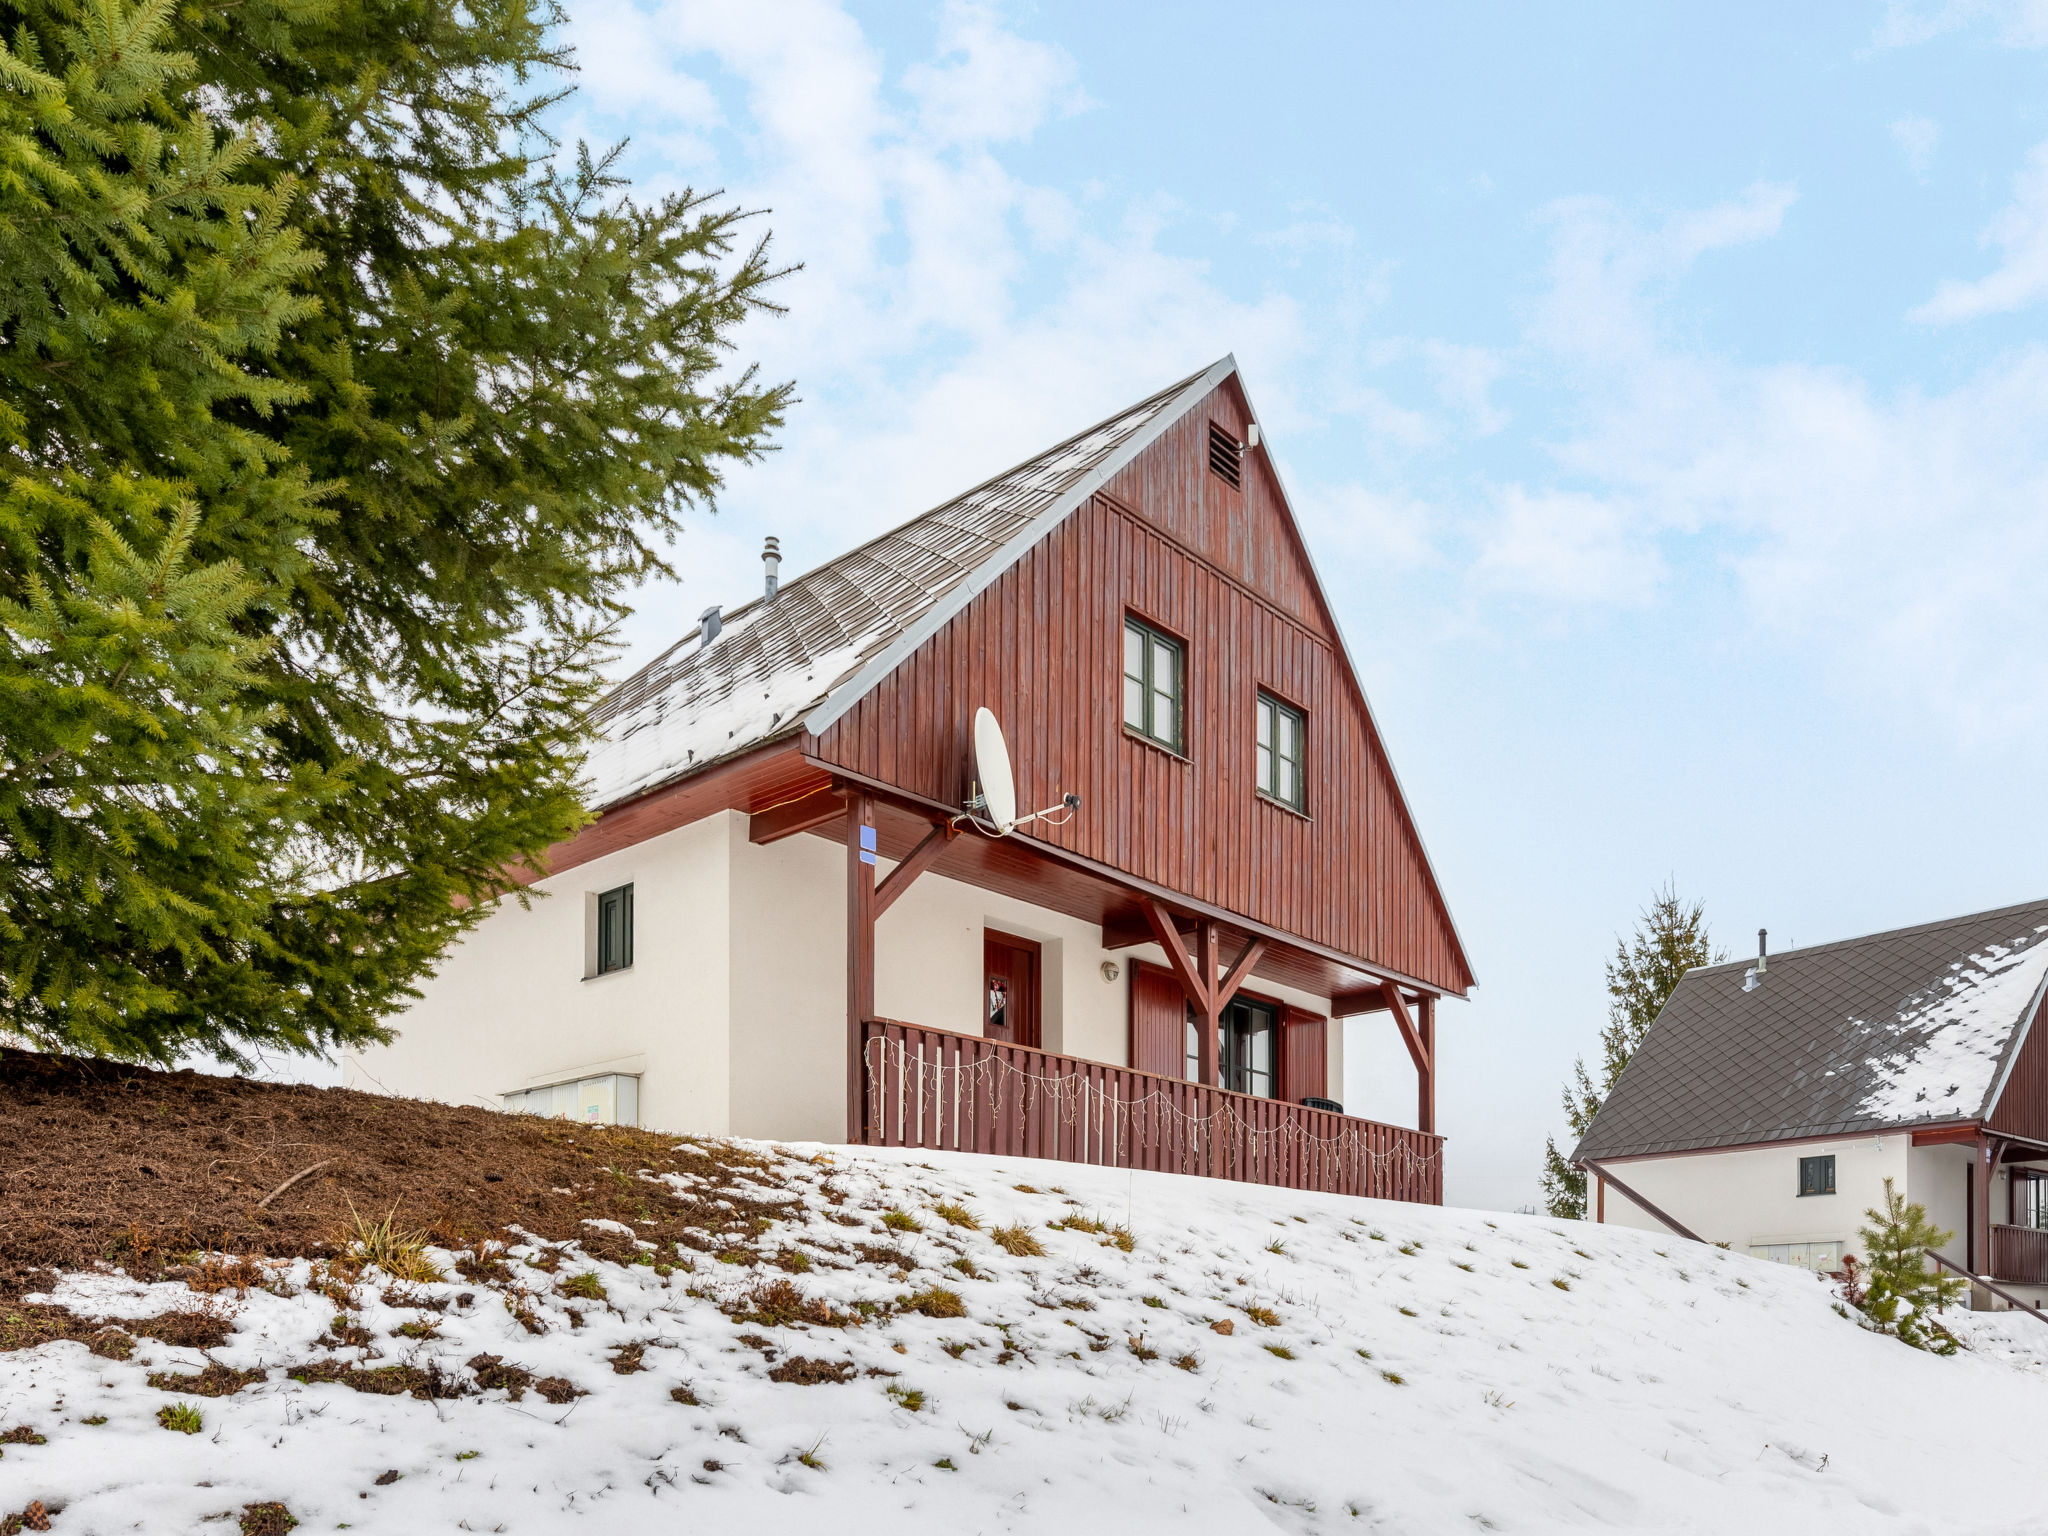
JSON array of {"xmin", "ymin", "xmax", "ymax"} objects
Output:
[{"xmin": 348, "ymin": 358, "xmax": 1473, "ymax": 1200}]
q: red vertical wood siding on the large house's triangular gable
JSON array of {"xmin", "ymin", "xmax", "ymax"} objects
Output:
[{"xmin": 815, "ymin": 381, "xmax": 1473, "ymax": 993}]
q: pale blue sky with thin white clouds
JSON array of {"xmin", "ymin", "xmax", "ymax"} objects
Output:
[{"xmin": 540, "ymin": 0, "xmax": 2048, "ymax": 1206}]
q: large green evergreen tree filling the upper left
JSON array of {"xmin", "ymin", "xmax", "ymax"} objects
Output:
[{"xmin": 0, "ymin": 0, "xmax": 788, "ymax": 1061}]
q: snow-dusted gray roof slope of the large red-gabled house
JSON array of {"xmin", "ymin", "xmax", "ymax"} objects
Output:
[{"xmin": 584, "ymin": 358, "xmax": 1231, "ymax": 811}]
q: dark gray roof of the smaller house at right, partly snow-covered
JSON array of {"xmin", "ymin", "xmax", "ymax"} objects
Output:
[{"xmin": 1573, "ymin": 901, "xmax": 2048, "ymax": 1159}]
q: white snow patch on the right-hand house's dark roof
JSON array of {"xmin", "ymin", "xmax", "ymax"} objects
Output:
[{"xmin": 1858, "ymin": 924, "xmax": 2048, "ymax": 1120}]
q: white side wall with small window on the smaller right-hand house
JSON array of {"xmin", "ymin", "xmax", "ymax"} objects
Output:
[{"xmin": 1589, "ymin": 1133, "xmax": 1900, "ymax": 1253}]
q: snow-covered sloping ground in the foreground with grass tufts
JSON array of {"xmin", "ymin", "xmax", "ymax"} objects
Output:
[{"xmin": 0, "ymin": 1147, "xmax": 2048, "ymax": 1536}]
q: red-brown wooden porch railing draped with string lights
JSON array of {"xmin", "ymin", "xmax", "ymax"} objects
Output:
[{"xmin": 862, "ymin": 1020, "xmax": 1444, "ymax": 1204}]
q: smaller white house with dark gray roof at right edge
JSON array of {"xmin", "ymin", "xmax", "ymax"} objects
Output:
[{"xmin": 1573, "ymin": 901, "xmax": 2048, "ymax": 1298}]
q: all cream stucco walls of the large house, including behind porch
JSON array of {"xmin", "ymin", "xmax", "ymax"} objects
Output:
[{"xmin": 344, "ymin": 811, "xmax": 1343, "ymax": 1141}]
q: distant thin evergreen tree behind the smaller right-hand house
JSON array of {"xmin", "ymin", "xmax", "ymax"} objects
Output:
[{"xmin": 1542, "ymin": 885, "xmax": 1726, "ymax": 1221}]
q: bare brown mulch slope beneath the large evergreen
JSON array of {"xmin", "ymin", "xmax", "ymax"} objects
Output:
[{"xmin": 0, "ymin": 1049, "xmax": 797, "ymax": 1300}]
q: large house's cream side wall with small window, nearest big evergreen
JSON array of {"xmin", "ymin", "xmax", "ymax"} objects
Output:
[{"xmin": 342, "ymin": 817, "xmax": 743, "ymax": 1135}]
